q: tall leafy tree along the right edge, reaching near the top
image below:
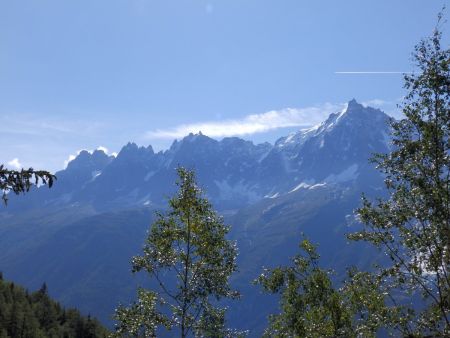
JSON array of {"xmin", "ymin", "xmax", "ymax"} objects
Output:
[{"xmin": 350, "ymin": 19, "xmax": 450, "ymax": 337}]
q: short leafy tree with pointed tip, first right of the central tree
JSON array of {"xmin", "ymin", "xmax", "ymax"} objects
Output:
[{"xmin": 256, "ymin": 240, "xmax": 351, "ymax": 337}]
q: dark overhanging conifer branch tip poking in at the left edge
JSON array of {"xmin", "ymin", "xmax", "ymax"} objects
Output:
[{"xmin": 0, "ymin": 165, "xmax": 56, "ymax": 204}]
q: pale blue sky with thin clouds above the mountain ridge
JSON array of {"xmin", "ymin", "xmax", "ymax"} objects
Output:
[{"xmin": 0, "ymin": 0, "xmax": 449, "ymax": 171}]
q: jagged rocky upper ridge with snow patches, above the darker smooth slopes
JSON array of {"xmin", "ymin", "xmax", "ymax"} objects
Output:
[{"xmin": 1, "ymin": 99, "xmax": 389, "ymax": 211}]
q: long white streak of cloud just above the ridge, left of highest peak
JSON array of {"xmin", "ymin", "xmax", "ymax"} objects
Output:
[{"xmin": 145, "ymin": 103, "xmax": 345, "ymax": 139}]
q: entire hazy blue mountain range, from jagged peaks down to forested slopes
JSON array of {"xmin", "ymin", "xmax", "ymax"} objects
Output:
[{"xmin": 0, "ymin": 100, "xmax": 390, "ymax": 337}]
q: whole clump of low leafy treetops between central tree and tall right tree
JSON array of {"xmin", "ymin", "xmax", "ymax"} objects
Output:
[{"xmin": 255, "ymin": 239, "xmax": 396, "ymax": 337}]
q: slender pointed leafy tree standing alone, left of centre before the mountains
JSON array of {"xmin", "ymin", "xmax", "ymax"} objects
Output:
[{"xmin": 115, "ymin": 168, "xmax": 244, "ymax": 337}]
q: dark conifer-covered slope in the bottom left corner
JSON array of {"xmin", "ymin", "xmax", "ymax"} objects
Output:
[{"xmin": 0, "ymin": 279, "xmax": 108, "ymax": 338}]
